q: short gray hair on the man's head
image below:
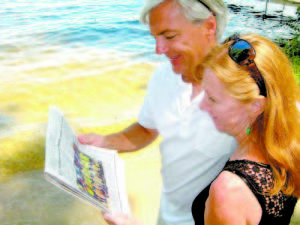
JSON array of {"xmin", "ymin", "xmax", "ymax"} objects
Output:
[{"xmin": 141, "ymin": 0, "xmax": 228, "ymax": 40}]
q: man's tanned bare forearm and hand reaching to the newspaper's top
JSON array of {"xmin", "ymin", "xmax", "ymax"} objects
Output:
[{"xmin": 78, "ymin": 122, "xmax": 158, "ymax": 152}]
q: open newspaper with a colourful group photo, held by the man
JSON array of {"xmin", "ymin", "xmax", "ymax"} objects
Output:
[{"xmin": 44, "ymin": 106, "xmax": 130, "ymax": 214}]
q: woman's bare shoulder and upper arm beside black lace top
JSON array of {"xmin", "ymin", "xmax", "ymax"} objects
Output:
[{"xmin": 204, "ymin": 171, "xmax": 262, "ymax": 225}]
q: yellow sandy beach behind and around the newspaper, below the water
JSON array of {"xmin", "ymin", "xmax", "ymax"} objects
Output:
[{"xmin": 0, "ymin": 60, "xmax": 300, "ymax": 225}]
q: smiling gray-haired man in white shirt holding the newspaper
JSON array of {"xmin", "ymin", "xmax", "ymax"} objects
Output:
[{"xmin": 78, "ymin": 0, "xmax": 236, "ymax": 225}]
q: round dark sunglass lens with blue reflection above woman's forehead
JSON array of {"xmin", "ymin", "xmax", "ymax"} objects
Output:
[{"xmin": 230, "ymin": 40, "xmax": 252, "ymax": 64}]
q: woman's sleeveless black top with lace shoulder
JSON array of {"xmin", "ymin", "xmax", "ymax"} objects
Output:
[{"xmin": 192, "ymin": 160, "xmax": 297, "ymax": 225}]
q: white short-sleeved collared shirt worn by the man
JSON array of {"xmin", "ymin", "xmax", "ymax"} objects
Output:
[{"xmin": 138, "ymin": 63, "xmax": 237, "ymax": 225}]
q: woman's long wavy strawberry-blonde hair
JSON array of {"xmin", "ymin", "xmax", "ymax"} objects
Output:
[{"xmin": 197, "ymin": 34, "xmax": 300, "ymax": 197}]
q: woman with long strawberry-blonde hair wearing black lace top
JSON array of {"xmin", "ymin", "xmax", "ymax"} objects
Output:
[{"xmin": 106, "ymin": 34, "xmax": 300, "ymax": 225}]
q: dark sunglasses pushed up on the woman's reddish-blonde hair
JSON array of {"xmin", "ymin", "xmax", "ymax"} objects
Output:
[{"xmin": 223, "ymin": 34, "xmax": 267, "ymax": 97}]
